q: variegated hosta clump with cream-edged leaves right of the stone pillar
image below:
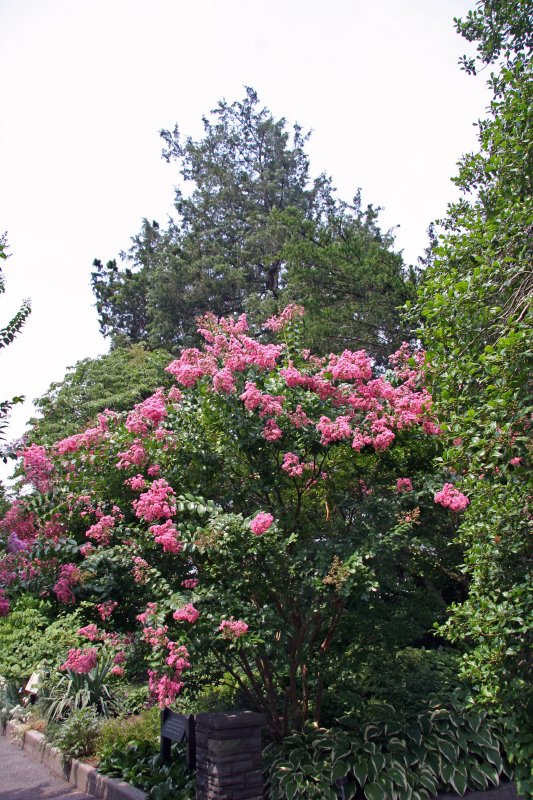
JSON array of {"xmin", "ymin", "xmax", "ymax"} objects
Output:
[{"xmin": 265, "ymin": 695, "xmax": 511, "ymax": 800}]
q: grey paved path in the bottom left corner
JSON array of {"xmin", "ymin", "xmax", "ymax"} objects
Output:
[{"xmin": 0, "ymin": 736, "xmax": 95, "ymax": 800}]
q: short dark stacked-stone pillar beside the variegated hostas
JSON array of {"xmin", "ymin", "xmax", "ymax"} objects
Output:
[{"xmin": 196, "ymin": 711, "xmax": 265, "ymax": 800}]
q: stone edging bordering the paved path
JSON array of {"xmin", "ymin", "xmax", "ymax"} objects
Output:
[{"xmin": 7, "ymin": 722, "xmax": 147, "ymax": 800}]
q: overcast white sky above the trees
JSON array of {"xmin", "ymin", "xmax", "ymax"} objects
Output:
[{"xmin": 0, "ymin": 0, "xmax": 488, "ymax": 476}]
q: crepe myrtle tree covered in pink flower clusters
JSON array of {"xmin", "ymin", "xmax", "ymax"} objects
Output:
[{"xmin": 1, "ymin": 306, "xmax": 468, "ymax": 738}]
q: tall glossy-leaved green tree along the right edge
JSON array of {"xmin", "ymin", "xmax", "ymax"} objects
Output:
[{"xmin": 417, "ymin": 0, "xmax": 533, "ymax": 796}]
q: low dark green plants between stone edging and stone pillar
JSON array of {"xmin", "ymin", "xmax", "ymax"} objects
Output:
[{"xmin": 98, "ymin": 741, "xmax": 195, "ymax": 800}]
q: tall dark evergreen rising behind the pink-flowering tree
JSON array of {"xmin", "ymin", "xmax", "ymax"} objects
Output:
[{"xmin": 92, "ymin": 88, "xmax": 414, "ymax": 356}]
